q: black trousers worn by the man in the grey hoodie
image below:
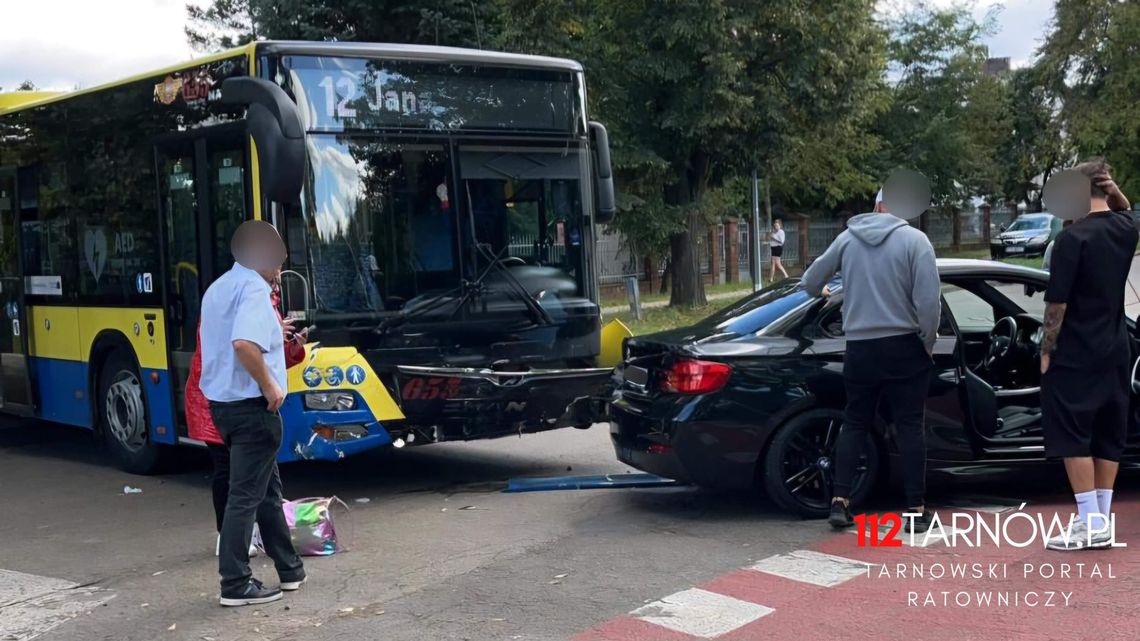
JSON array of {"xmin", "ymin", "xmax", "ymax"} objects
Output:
[{"xmin": 834, "ymin": 334, "xmax": 933, "ymax": 508}]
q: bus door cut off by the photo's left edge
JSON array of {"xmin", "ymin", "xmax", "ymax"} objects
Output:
[{"xmin": 0, "ymin": 169, "xmax": 34, "ymax": 415}]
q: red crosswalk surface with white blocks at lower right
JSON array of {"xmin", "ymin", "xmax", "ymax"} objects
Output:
[{"xmin": 575, "ymin": 498, "xmax": 1140, "ymax": 641}]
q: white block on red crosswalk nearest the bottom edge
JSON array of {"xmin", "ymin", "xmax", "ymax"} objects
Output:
[{"xmin": 629, "ymin": 587, "xmax": 775, "ymax": 639}]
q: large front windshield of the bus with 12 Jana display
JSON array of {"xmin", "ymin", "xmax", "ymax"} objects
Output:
[{"xmin": 276, "ymin": 56, "xmax": 589, "ymax": 316}]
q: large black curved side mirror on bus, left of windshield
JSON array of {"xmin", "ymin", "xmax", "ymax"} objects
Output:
[{"xmin": 221, "ymin": 78, "xmax": 306, "ymax": 203}]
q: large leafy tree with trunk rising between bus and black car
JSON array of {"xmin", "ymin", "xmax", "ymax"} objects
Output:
[{"xmin": 503, "ymin": 0, "xmax": 884, "ymax": 306}]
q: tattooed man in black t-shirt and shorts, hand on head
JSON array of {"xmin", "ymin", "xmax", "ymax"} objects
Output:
[{"xmin": 1041, "ymin": 161, "xmax": 1138, "ymax": 550}]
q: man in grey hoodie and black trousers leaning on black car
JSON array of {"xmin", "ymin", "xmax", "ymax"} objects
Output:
[{"xmin": 803, "ymin": 180, "xmax": 942, "ymax": 532}]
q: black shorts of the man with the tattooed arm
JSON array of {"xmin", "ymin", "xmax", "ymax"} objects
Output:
[{"xmin": 1041, "ymin": 360, "xmax": 1132, "ymax": 461}]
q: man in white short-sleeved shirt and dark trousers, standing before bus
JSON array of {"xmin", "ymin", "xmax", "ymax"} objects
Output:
[{"xmin": 200, "ymin": 220, "xmax": 306, "ymax": 606}]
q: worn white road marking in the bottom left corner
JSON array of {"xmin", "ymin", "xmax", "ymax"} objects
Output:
[{"xmin": 0, "ymin": 569, "xmax": 115, "ymax": 641}]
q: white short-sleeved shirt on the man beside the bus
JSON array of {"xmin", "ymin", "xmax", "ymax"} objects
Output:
[{"xmin": 198, "ymin": 263, "xmax": 288, "ymax": 403}]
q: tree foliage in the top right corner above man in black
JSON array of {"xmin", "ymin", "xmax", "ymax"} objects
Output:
[{"xmin": 1039, "ymin": 0, "xmax": 1140, "ymax": 194}]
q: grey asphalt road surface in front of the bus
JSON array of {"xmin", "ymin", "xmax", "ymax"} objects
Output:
[{"xmin": 0, "ymin": 415, "xmax": 1135, "ymax": 641}]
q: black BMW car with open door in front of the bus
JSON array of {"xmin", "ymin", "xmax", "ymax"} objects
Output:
[{"xmin": 610, "ymin": 260, "xmax": 1140, "ymax": 517}]
